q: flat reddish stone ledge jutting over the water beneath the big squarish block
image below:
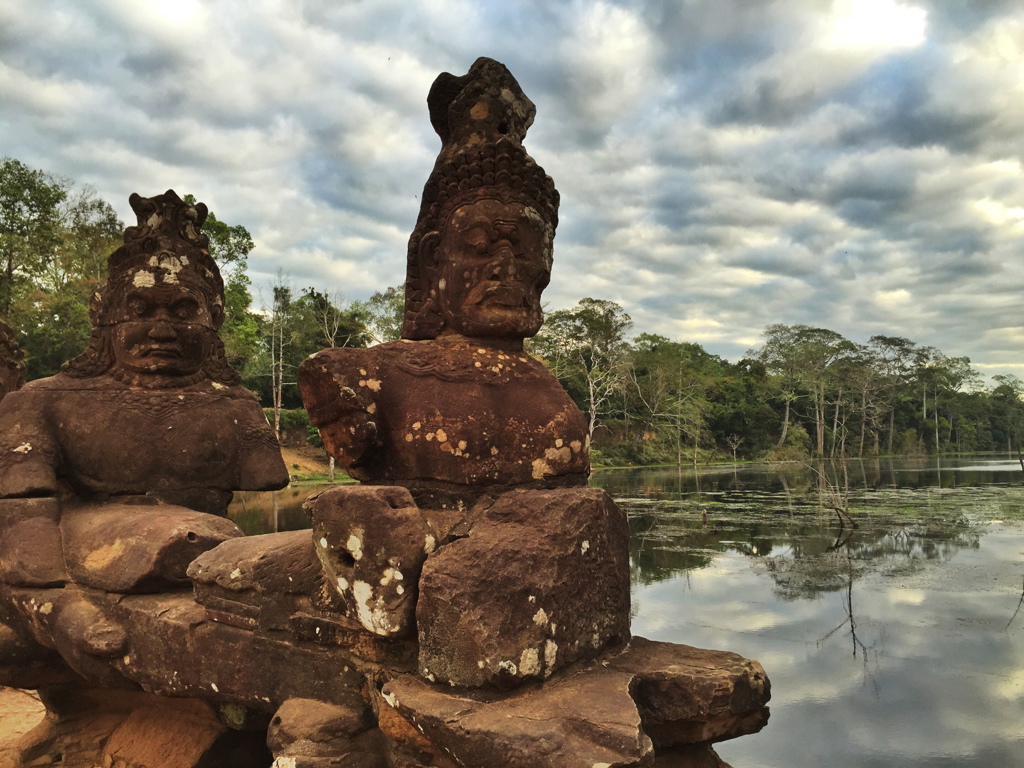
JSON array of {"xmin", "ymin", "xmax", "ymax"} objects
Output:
[{"xmin": 378, "ymin": 638, "xmax": 771, "ymax": 768}]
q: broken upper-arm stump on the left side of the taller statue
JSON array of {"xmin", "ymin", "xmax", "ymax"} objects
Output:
[{"xmin": 298, "ymin": 348, "xmax": 383, "ymax": 479}]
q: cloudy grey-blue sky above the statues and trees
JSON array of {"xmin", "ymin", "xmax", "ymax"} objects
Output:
[{"xmin": 0, "ymin": 0, "xmax": 1024, "ymax": 378}]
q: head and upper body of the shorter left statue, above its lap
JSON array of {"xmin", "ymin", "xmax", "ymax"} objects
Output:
[{"xmin": 0, "ymin": 191, "xmax": 288, "ymax": 514}]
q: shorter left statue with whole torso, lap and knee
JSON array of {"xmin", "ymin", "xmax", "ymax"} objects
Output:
[{"xmin": 0, "ymin": 191, "xmax": 288, "ymax": 765}]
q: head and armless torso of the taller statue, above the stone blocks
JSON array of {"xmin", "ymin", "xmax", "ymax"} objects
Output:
[{"xmin": 299, "ymin": 59, "xmax": 590, "ymax": 507}]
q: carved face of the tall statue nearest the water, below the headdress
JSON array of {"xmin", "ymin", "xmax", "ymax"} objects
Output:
[{"xmin": 435, "ymin": 199, "xmax": 551, "ymax": 339}]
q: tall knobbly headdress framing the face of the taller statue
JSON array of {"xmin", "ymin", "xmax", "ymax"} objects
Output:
[{"xmin": 401, "ymin": 58, "xmax": 558, "ymax": 339}]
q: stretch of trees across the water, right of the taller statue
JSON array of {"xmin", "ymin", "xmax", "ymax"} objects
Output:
[{"xmin": 530, "ymin": 298, "xmax": 1024, "ymax": 464}]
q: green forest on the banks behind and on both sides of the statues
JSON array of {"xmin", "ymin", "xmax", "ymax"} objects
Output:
[{"xmin": 0, "ymin": 159, "xmax": 1024, "ymax": 464}]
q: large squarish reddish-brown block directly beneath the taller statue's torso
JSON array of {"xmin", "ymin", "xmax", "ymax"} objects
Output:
[{"xmin": 416, "ymin": 488, "xmax": 630, "ymax": 687}]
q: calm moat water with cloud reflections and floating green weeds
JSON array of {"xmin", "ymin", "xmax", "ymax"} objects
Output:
[{"xmin": 232, "ymin": 458, "xmax": 1024, "ymax": 768}]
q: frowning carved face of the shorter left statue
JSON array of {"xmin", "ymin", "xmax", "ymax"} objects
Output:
[{"xmin": 113, "ymin": 284, "xmax": 215, "ymax": 376}]
